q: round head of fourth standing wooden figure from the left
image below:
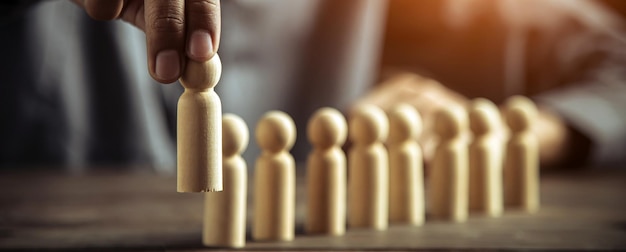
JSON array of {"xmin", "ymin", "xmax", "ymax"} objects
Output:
[{"xmin": 349, "ymin": 105, "xmax": 389, "ymax": 144}]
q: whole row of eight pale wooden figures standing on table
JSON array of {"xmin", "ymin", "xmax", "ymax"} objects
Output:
[{"xmin": 203, "ymin": 96, "xmax": 539, "ymax": 247}]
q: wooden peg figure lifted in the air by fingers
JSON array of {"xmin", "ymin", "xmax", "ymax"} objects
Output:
[{"xmin": 177, "ymin": 54, "xmax": 222, "ymax": 192}]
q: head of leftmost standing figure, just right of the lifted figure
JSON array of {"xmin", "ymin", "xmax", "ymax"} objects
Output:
[{"xmin": 222, "ymin": 114, "xmax": 250, "ymax": 157}]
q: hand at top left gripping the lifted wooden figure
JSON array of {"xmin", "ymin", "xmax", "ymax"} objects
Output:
[{"xmin": 73, "ymin": 0, "xmax": 220, "ymax": 83}]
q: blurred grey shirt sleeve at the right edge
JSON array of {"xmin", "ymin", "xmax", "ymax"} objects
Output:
[{"xmin": 535, "ymin": 49, "xmax": 626, "ymax": 164}]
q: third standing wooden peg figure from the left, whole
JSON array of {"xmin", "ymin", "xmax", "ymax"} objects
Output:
[{"xmin": 305, "ymin": 108, "xmax": 348, "ymax": 235}]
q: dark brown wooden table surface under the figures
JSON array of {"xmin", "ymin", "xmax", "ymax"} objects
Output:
[{"xmin": 0, "ymin": 168, "xmax": 626, "ymax": 251}]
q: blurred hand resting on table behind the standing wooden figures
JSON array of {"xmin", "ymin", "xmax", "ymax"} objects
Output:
[{"xmin": 353, "ymin": 73, "xmax": 591, "ymax": 168}]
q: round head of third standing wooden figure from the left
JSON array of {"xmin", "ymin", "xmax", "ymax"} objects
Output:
[{"xmin": 307, "ymin": 108, "xmax": 348, "ymax": 148}]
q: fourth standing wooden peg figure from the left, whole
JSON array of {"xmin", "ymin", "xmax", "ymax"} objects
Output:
[{"xmin": 348, "ymin": 105, "xmax": 389, "ymax": 230}]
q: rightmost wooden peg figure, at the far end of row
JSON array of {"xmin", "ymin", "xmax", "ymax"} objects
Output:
[{"xmin": 504, "ymin": 96, "xmax": 539, "ymax": 212}]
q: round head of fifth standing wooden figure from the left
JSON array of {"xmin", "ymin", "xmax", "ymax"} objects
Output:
[{"xmin": 387, "ymin": 104, "xmax": 422, "ymax": 143}]
